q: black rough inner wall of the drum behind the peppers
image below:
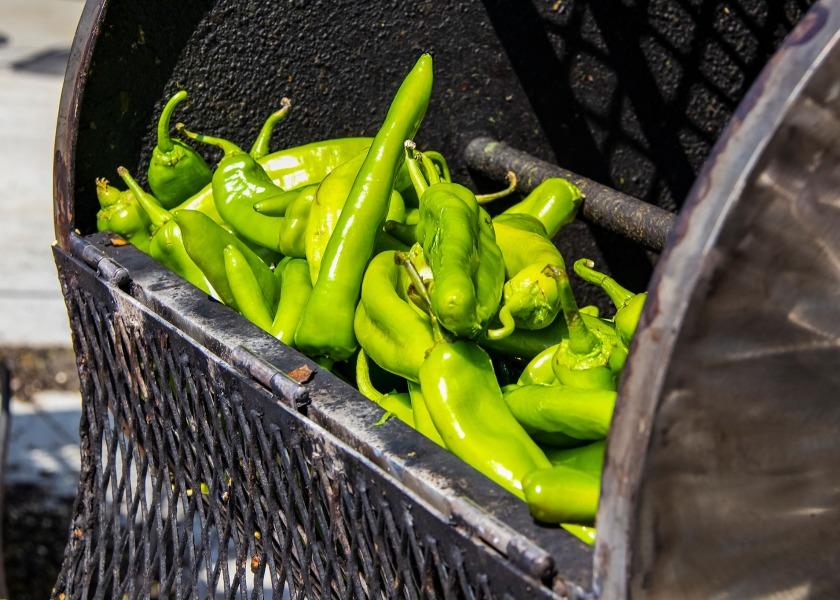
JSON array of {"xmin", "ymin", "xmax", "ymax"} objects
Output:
[{"xmin": 57, "ymin": 0, "xmax": 809, "ymax": 292}]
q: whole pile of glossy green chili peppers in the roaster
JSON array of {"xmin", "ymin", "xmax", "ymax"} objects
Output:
[{"xmin": 96, "ymin": 54, "xmax": 646, "ymax": 543}]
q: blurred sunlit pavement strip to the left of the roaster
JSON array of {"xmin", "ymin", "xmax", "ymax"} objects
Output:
[{"xmin": 0, "ymin": 0, "xmax": 84, "ymax": 598}]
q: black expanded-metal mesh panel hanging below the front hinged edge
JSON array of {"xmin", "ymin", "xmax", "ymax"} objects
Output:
[{"xmin": 53, "ymin": 245, "xmax": 564, "ymax": 599}]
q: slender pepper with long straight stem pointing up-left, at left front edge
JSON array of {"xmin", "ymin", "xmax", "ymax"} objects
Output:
[{"xmin": 117, "ymin": 167, "xmax": 213, "ymax": 294}]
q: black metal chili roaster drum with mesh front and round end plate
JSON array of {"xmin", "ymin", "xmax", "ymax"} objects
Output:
[{"xmin": 53, "ymin": 0, "xmax": 840, "ymax": 599}]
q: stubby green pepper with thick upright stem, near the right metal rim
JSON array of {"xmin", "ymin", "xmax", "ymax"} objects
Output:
[{"xmin": 552, "ymin": 269, "xmax": 627, "ymax": 390}]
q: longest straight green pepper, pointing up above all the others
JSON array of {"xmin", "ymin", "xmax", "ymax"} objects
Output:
[{"xmin": 295, "ymin": 54, "xmax": 433, "ymax": 360}]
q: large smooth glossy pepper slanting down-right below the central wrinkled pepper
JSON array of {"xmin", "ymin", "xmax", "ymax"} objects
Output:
[{"xmin": 420, "ymin": 341, "xmax": 551, "ymax": 498}]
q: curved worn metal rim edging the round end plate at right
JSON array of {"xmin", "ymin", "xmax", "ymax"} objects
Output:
[{"xmin": 594, "ymin": 1, "xmax": 840, "ymax": 598}]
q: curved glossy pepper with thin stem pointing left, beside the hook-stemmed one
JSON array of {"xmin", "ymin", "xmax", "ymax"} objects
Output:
[{"xmin": 176, "ymin": 123, "xmax": 285, "ymax": 252}]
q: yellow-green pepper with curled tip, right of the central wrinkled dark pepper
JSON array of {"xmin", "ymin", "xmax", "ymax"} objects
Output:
[{"xmin": 487, "ymin": 222, "xmax": 565, "ymax": 339}]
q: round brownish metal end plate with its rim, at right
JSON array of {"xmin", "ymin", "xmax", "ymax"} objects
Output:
[{"xmin": 595, "ymin": 0, "xmax": 840, "ymax": 598}]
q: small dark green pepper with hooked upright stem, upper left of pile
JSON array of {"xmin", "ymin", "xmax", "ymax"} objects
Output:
[{"xmin": 147, "ymin": 90, "xmax": 213, "ymax": 208}]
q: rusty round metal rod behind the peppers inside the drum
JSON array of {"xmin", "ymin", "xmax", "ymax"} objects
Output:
[{"xmin": 464, "ymin": 137, "xmax": 677, "ymax": 252}]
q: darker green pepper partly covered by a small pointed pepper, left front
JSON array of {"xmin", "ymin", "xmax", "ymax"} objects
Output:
[{"xmin": 172, "ymin": 210, "xmax": 278, "ymax": 310}]
